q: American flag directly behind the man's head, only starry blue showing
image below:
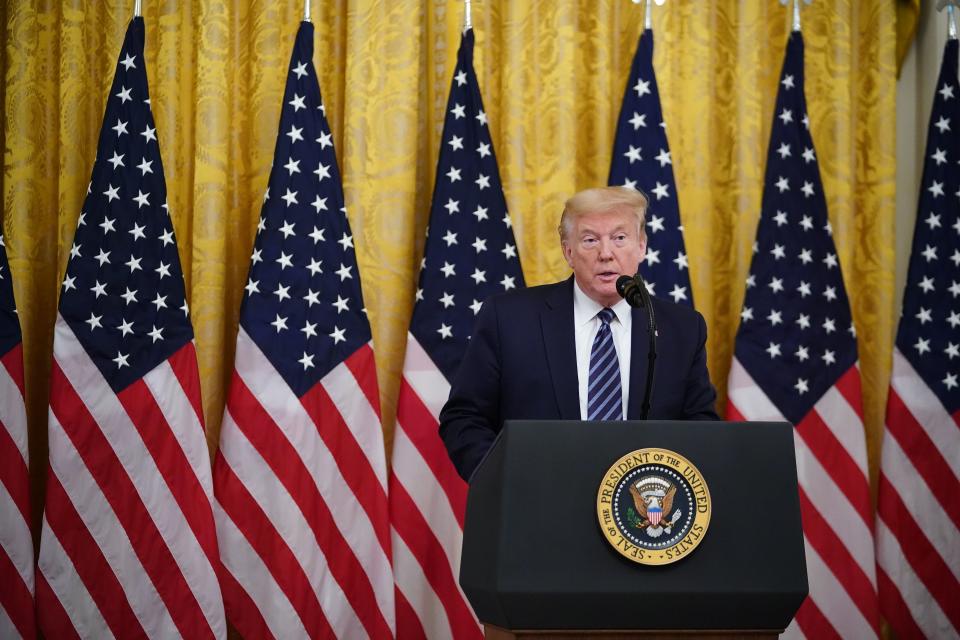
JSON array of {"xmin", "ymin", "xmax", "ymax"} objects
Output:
[{"xmin": 608, "ymin": 29, "xmax": 693, "ymax": 306}]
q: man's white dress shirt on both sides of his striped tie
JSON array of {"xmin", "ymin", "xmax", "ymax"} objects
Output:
[{"xmin": 573, "ymin": 280, "xmax": 633, "ymax": 420}]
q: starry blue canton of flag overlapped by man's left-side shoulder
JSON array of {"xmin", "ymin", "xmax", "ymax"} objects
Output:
[{"xmin": 410, "ymin": 30, "xmax": 524, "ymax": 380}]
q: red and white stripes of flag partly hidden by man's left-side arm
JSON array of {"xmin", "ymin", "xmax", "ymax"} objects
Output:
[{"xmin": 390, "ymin": 333, "xmax": 482, "ymax": 639}]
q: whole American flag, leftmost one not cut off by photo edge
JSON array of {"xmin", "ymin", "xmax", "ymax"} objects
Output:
[{"xmin": 37, "ymin": 18, "xmax": 226, "ymax": 638}]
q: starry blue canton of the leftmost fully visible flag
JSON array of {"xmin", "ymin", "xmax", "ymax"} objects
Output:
[{"xmin": 60, "ymin": 18, "xmax": 193, "ymax": 391}]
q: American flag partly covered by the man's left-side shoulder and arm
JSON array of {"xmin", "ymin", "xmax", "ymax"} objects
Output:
[{"xmin": 390, "ymin": 30, "xmax": 524, "ymax": 639}]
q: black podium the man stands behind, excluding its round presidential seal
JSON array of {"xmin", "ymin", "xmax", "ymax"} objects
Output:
[{"xmin": 460, "ymin": 421, "xmax": 807, "ymax": 640}]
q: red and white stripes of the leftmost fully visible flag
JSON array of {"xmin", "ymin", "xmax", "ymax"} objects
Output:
[{"xmin": 37, "ymin": 317, "xmax": 226, "ymax": 638}]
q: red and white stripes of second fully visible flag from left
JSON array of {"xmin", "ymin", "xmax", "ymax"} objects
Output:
[{"xmin": 214, "ymin": 328, "xmax": 395, "ymax": 638}]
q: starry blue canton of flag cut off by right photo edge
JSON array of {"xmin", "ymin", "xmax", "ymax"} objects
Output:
[{"xmin": 897, "ymin": 40, "xmax": 960, "ymax": 413}]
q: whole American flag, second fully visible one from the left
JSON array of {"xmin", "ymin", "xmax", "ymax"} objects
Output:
[{"xmin": 214, "ymin": 22, "xmax": 394, "ymax": 638}]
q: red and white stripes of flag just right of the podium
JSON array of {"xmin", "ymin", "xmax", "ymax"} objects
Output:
[{"xmin": 727, "ymin": 359, "xmax": 879, "ymax": 638}]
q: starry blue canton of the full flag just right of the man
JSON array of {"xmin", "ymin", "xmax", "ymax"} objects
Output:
[{"xmin": 735, "ymin": 32, "xmax": 857, "ymax": 424}]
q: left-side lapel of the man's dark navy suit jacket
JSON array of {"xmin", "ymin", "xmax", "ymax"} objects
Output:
[{"xmin": 540, "ymin": 276, "xmax": 580, "ymax": 420}]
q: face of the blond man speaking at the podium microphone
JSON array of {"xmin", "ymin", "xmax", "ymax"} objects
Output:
[{"xmin": 562, "ymin": 207, "xmax": 647, "ymax": 307}]
